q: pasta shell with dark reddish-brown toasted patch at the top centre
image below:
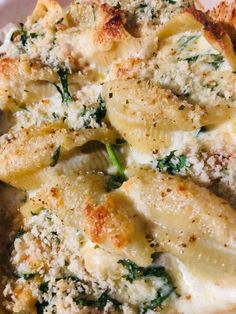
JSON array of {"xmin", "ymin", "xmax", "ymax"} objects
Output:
[{"xmin": 57, "ymin": 2, "xmax": 157, "ymax": 67}]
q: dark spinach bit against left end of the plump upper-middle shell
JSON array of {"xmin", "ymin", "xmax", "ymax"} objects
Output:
[{"xmin": 80, "ymin": 94, "xmax": 107, "ymax": 129}]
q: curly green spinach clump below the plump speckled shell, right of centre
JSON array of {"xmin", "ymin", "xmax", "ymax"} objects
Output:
[{"xmin": 156, "ymin": 151, "xmax": 187, "ymax": 174}]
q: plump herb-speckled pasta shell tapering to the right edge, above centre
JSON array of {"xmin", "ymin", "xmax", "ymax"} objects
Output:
[{"xmin": 103, "ymin": 80, "xmax": 236, "ymax": 151}]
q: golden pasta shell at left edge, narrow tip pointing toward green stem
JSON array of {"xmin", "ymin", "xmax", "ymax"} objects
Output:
[{"xmin": 0, "ymin": 123, "xmax": 115, "ymax": 189}]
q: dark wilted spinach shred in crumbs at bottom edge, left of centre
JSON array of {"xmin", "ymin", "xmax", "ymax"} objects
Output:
[{"xmin": 74, "ymin": 291, "xmax": 121, "ymax": 310}]
